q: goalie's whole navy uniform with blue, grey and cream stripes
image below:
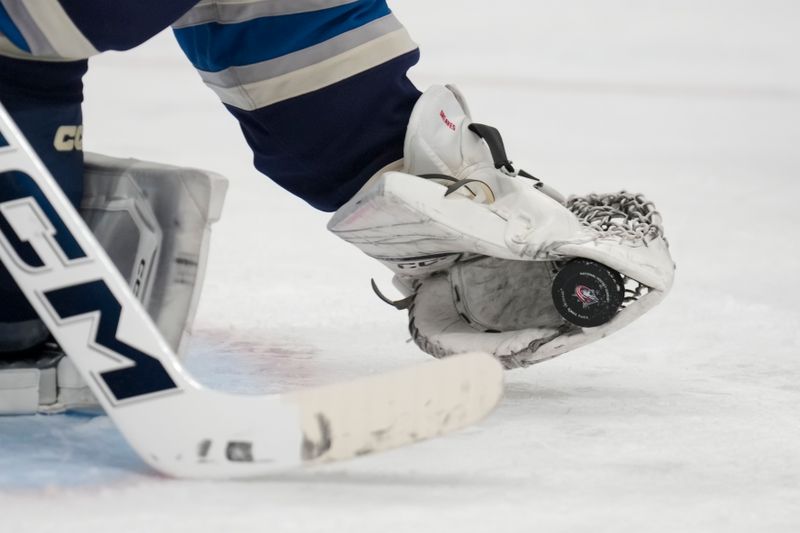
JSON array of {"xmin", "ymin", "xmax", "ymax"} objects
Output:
[{"xmin": 0, "ymin": 0, "xmax": 420, "ymax": 350}]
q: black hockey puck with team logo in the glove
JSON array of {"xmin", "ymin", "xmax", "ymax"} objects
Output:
[{"xmin": 553, "ymin": 259, "xmax": 625, "ymax": 328}]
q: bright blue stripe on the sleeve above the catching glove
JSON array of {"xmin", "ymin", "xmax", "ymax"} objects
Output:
[{"xmin": 175, "ymin": 0, "xmax": 391, "ymax": 72}]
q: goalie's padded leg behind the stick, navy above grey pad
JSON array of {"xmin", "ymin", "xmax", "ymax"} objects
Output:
[{"xmin": 0, "ymin": 70, "xmax": 226, "ymax": 414}]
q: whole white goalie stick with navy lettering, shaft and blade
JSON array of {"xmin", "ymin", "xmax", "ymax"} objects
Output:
[{"xmin": 0, "ymin": 105, "xmax": 503, "ymax": 478}]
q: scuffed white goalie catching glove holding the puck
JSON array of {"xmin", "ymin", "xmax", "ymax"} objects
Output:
[{"xmin": 328, "ymin": 86, "xmax": 674, "ymax": 368}]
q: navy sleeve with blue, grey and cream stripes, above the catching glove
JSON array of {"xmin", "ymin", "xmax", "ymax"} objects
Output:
[{"xmin": 174, "ymin": 0, "xmax": 420, "ymax": 211}]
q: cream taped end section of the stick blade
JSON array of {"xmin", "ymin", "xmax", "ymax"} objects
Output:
[{"xmin": 284, "ymin": 353, "xmax": 503, "ymax": 463}]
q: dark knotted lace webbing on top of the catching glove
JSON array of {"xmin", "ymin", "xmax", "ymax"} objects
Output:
[{"xmin": 566, "ymin": 191, "xmax": 664, "ymax": 245}]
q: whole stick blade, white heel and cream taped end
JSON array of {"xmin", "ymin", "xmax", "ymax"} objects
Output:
[{"xmin": 124, "ymin": 353, "xmax": 503, "ymax": 479}]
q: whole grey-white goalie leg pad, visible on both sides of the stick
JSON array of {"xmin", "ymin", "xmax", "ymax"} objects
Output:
[{"xmin": 0, "ymin": 153, "xmax": 228, "ymax": 414}]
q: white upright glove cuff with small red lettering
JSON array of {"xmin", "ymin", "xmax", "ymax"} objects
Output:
[{"xmin": 404, "ymin": 85, "xmax": 494, "ymax": 179}]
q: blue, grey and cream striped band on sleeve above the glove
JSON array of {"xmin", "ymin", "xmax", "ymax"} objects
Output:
[{"xmin": 173, "ymin": 0, "xmax": 417, "ymax": 110}]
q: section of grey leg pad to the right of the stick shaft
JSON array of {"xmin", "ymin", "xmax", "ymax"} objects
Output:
[{"xmin": 81, "ymin": 153, "xmax": 228, "ymax": 353}]
